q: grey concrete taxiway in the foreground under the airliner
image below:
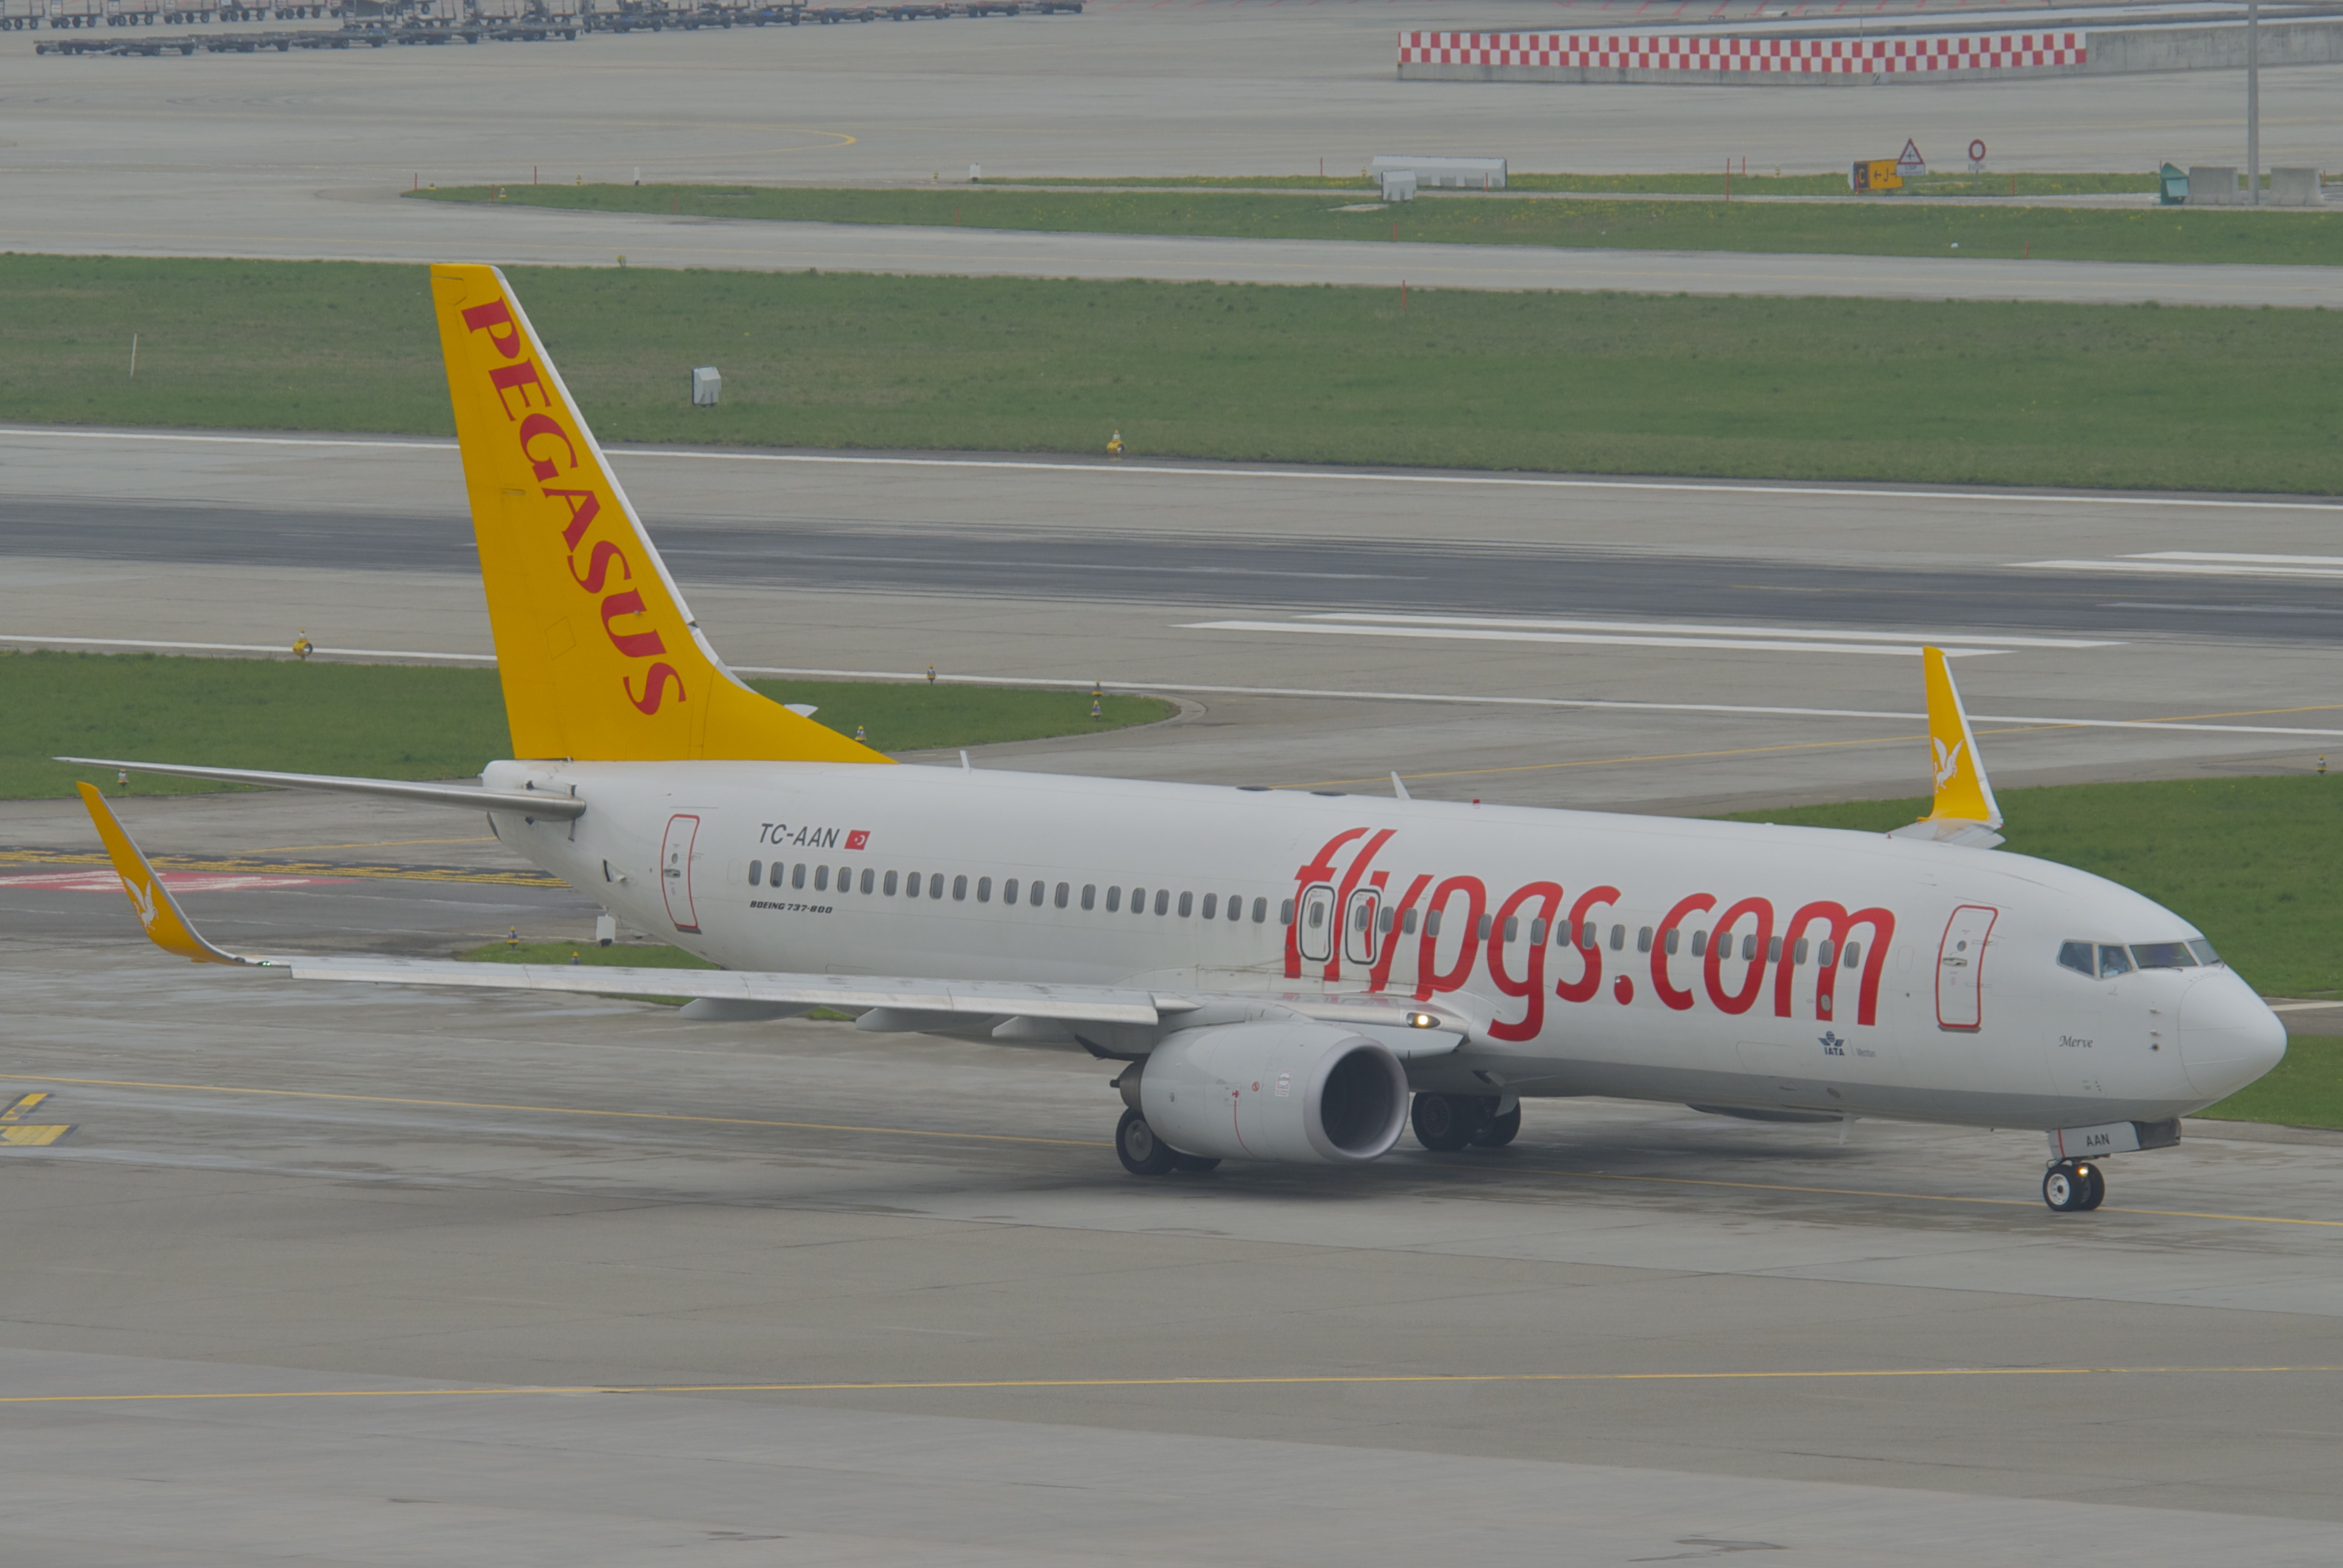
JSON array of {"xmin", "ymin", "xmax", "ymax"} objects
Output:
[{"xmin": 0, "ymin": 797, "xmax": 2343, "ymax": 1566}]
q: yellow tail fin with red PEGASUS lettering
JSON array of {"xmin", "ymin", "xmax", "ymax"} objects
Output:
[{"xmin": 431, "ymin": 267, "xmax": 888, "ymax": 762}]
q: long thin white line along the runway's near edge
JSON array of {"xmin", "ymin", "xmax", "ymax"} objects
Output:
[{"xmin": 0, "ymin": 635, "xmax": 2343, "ymax": 738}]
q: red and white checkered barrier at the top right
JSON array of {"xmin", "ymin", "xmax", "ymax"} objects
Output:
[{"xmin": 1399, "ymin": 33, "xmax": 2088, "ymax": 75}]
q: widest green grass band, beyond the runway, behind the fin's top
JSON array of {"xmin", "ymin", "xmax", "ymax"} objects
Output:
[{"xmin": 0, "ymin": 255, "xmax": 2343, "ymax": 492}]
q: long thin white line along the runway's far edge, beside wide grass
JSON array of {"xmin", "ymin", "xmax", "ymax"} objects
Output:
[{"xmin": 0, "ymin": 424, "xmax": 2343, "ymax": 513}]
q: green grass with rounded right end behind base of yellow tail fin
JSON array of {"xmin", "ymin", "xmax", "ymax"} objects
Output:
[{"xmin": 0, "ymin": 651, "xmax": 1174, "ymax": 800}]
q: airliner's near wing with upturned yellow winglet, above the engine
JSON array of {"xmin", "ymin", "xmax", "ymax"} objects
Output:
[{"xmin": 80, "ymin": 783, "xmax": 1472, "ymax": 1055}]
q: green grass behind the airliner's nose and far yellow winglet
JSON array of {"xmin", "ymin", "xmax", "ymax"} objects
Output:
[{"xmin": 1736, "ymin": 774, "xmax": 2343, "ymax": 996}]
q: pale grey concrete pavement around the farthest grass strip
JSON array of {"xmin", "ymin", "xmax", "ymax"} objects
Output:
[{"xmin": 0, "ymin": 0, "xmax": 2343, "ymax": 307}]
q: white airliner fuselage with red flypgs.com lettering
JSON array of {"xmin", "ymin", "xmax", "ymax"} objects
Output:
[{"xmin": 485, "ymin": 762, "xmax": 2285, "ymax": 1128}]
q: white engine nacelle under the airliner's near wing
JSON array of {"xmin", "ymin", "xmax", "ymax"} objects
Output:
[{"xmin": 1136, "ymin": 1019, "xmax": 1408, "ymax": 1165}]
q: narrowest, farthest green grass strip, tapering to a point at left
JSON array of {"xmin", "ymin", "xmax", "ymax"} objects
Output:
[{"xmin": 410, "ymin": 185, "xmax": 2343, "ymax": 267}]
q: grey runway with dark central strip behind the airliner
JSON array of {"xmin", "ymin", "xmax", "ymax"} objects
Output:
[{"xmin": 0, "ymin": 429, "xmax": 2343, "ymax": 811}]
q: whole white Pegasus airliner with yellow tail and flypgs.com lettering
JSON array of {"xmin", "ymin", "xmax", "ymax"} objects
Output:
[{"xmin": 73, "ymin": 267, "xmax": 2285, "ymax": 1212}]
